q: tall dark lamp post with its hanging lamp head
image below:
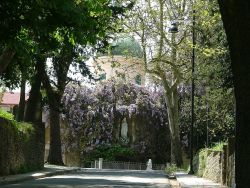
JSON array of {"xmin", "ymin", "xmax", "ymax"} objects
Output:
[{"xmin": 168, "ymin": 4, "xmax": 196, "ymax": 174}]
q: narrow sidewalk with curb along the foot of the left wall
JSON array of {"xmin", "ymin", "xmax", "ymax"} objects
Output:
[{"xmin": 0, "ymin": 168, "xmax": 80, "ymax": 186}]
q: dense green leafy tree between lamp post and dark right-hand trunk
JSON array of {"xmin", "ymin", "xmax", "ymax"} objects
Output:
[{"xmin": 179, "ymin": 0, "xmax": 235, "ymax": 151}]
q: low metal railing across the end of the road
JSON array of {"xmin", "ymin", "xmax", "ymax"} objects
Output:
[{"xmin": 91, "ymin": 161, "xmax": 166, "ymax": 170}]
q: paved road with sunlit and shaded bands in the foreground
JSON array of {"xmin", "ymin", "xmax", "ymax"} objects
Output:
[{"xmin": 2, "ymin": 169, "xmax": 171, "ymax": 188}]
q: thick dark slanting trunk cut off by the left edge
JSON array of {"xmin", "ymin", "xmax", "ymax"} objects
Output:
[{"xmin": 0, "ymin": 47, "xmax": 16, "ymax": 75}]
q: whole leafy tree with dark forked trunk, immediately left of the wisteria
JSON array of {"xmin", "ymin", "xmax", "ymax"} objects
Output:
[{"xmin": 37, "ymin": 1, "xmax": 133, "ymax": 164}]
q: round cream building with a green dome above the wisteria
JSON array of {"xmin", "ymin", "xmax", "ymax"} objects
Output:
[{"xmin": 93, "ymin": 37, "xmax": 145, "ymax": 86}]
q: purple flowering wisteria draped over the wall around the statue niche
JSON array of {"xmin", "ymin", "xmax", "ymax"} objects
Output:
[{"xmin": 62, "ymin": 80, "xmax": 167, "ymax": 157}]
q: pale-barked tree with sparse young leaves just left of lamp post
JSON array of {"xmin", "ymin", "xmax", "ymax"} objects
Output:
[{"xmin": 125, "ymin": 0, "xmax": 194, "ymax": 166}]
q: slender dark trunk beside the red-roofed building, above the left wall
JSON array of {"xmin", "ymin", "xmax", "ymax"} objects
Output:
[{"xmin": 17, "ymin": 75, "xmax": 26, "ymax": 121}]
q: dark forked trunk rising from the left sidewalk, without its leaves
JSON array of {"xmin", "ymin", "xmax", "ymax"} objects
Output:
[{"xmin": 42, "ymin": 45, "xmax": 74, "ymax": 165}]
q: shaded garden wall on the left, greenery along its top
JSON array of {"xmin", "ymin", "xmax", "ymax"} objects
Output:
[{"xmin": 0, "ymin": 117, "xmax": 44, "ymax": 176}]
